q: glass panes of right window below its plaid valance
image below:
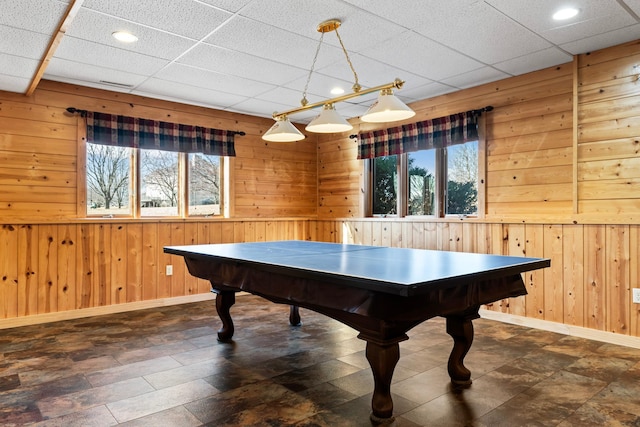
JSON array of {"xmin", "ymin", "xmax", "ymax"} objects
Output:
[{"xmin": 368, "ymin": 141, "xmax": 479, "ymax": 217}]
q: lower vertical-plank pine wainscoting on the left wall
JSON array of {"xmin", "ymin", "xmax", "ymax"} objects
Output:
[{"xmin": 0, "ymin": 219, "xmax": 315, "ymax": 329}]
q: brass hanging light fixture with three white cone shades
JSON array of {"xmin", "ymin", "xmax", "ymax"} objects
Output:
[{"xmin": 262, "ymin": 19, "xmax": 416, "ymax": 142}]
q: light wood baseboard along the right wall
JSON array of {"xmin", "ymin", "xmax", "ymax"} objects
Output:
[{"xmin": 480, "ymin": 309, "xmax": 640, "ymax": 348}]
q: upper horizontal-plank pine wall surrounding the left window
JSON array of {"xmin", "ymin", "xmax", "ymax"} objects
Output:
[{"xmin": 0, "ymin": 81, "xmax": 318, "ymax": 222}]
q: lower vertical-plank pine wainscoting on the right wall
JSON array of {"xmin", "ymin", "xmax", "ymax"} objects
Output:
[{"xmin": 316, "ymin": 219, "xmax": 640, "ymax": 344}]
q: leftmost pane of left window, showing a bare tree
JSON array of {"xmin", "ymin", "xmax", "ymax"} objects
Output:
[{"xmin": 87, "ymin": 143, "xmax": 131, "ymax": 215}]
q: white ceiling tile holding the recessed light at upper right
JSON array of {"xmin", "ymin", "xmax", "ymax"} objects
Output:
[{"xmin": 487, "ymin": 0, "xmax": 636, "ymax": 45}]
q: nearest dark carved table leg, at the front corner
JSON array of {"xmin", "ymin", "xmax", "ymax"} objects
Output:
[{"xmin": 366, "ymin": 341, "xmax": 400, "ymax": 423}]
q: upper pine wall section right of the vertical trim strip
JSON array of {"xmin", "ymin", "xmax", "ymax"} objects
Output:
[{"xmin": 577, "ymin": 41, "xmax": 640, "ymax": 221}]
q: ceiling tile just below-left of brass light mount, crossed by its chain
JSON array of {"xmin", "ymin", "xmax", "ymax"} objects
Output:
[{"xmin": 205, "ymin": 16, "xmax": 342, "ymax": 69}]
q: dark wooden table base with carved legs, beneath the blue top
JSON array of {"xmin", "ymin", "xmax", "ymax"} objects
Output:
[{"xmin": 178, "ymin": 255, "xmax": 527, "ymax": 420}]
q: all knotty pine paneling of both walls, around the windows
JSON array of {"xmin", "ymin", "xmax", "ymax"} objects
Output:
[{"xmin": 0, "ymin": 42, "xmax": 640, "ymax": 342}]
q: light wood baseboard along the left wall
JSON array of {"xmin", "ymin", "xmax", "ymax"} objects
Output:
[{"xmin": 0, "ymin": 292, "xmax": 216, "ymax": 329}]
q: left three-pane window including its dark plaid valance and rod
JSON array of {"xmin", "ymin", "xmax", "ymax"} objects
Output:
[{"xmin": 81, "ymin": 111, "xmax": 235, "ymax": 218}]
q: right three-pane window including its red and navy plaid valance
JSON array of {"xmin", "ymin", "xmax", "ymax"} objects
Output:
[{"xmin": 358, "ymin": 110, "xmax": 484, "ymax": 217}]
